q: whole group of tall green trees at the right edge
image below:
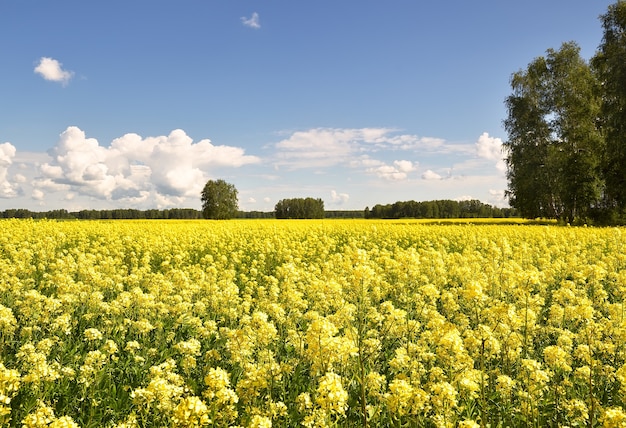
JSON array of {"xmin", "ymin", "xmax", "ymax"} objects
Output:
[{"xmin": 503, "ymin": 1, "xmax": 626, "ymax": 223}]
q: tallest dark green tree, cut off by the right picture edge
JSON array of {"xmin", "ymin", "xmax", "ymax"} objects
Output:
[{"xmin": 591, "ymin": 1, "xmax": 626, "ymax": 214}]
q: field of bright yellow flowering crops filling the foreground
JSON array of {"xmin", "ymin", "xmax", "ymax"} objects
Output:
[{"xmin": 0, "ymin": 220, "xmax": 626, "ymax": 428}]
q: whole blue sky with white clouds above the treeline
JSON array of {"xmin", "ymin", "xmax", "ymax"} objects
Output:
[{"xmin": 0, "ymin": 0, "xmax": 613, "ymax": 211}]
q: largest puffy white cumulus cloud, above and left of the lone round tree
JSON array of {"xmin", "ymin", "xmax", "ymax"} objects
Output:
[{"xmin": 33, "ymin": 126, "xmax": 259, "ymax": 206}]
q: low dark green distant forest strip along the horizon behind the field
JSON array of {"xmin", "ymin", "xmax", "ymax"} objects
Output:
[{"xmin": 0, "ymin": 200, "xmax": 517, "ymax": 220}]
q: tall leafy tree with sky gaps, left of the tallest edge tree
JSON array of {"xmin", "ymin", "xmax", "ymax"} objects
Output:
[{"xmin": 504, "ymin": 42, "xmax": 602, "ymax": 221}]
